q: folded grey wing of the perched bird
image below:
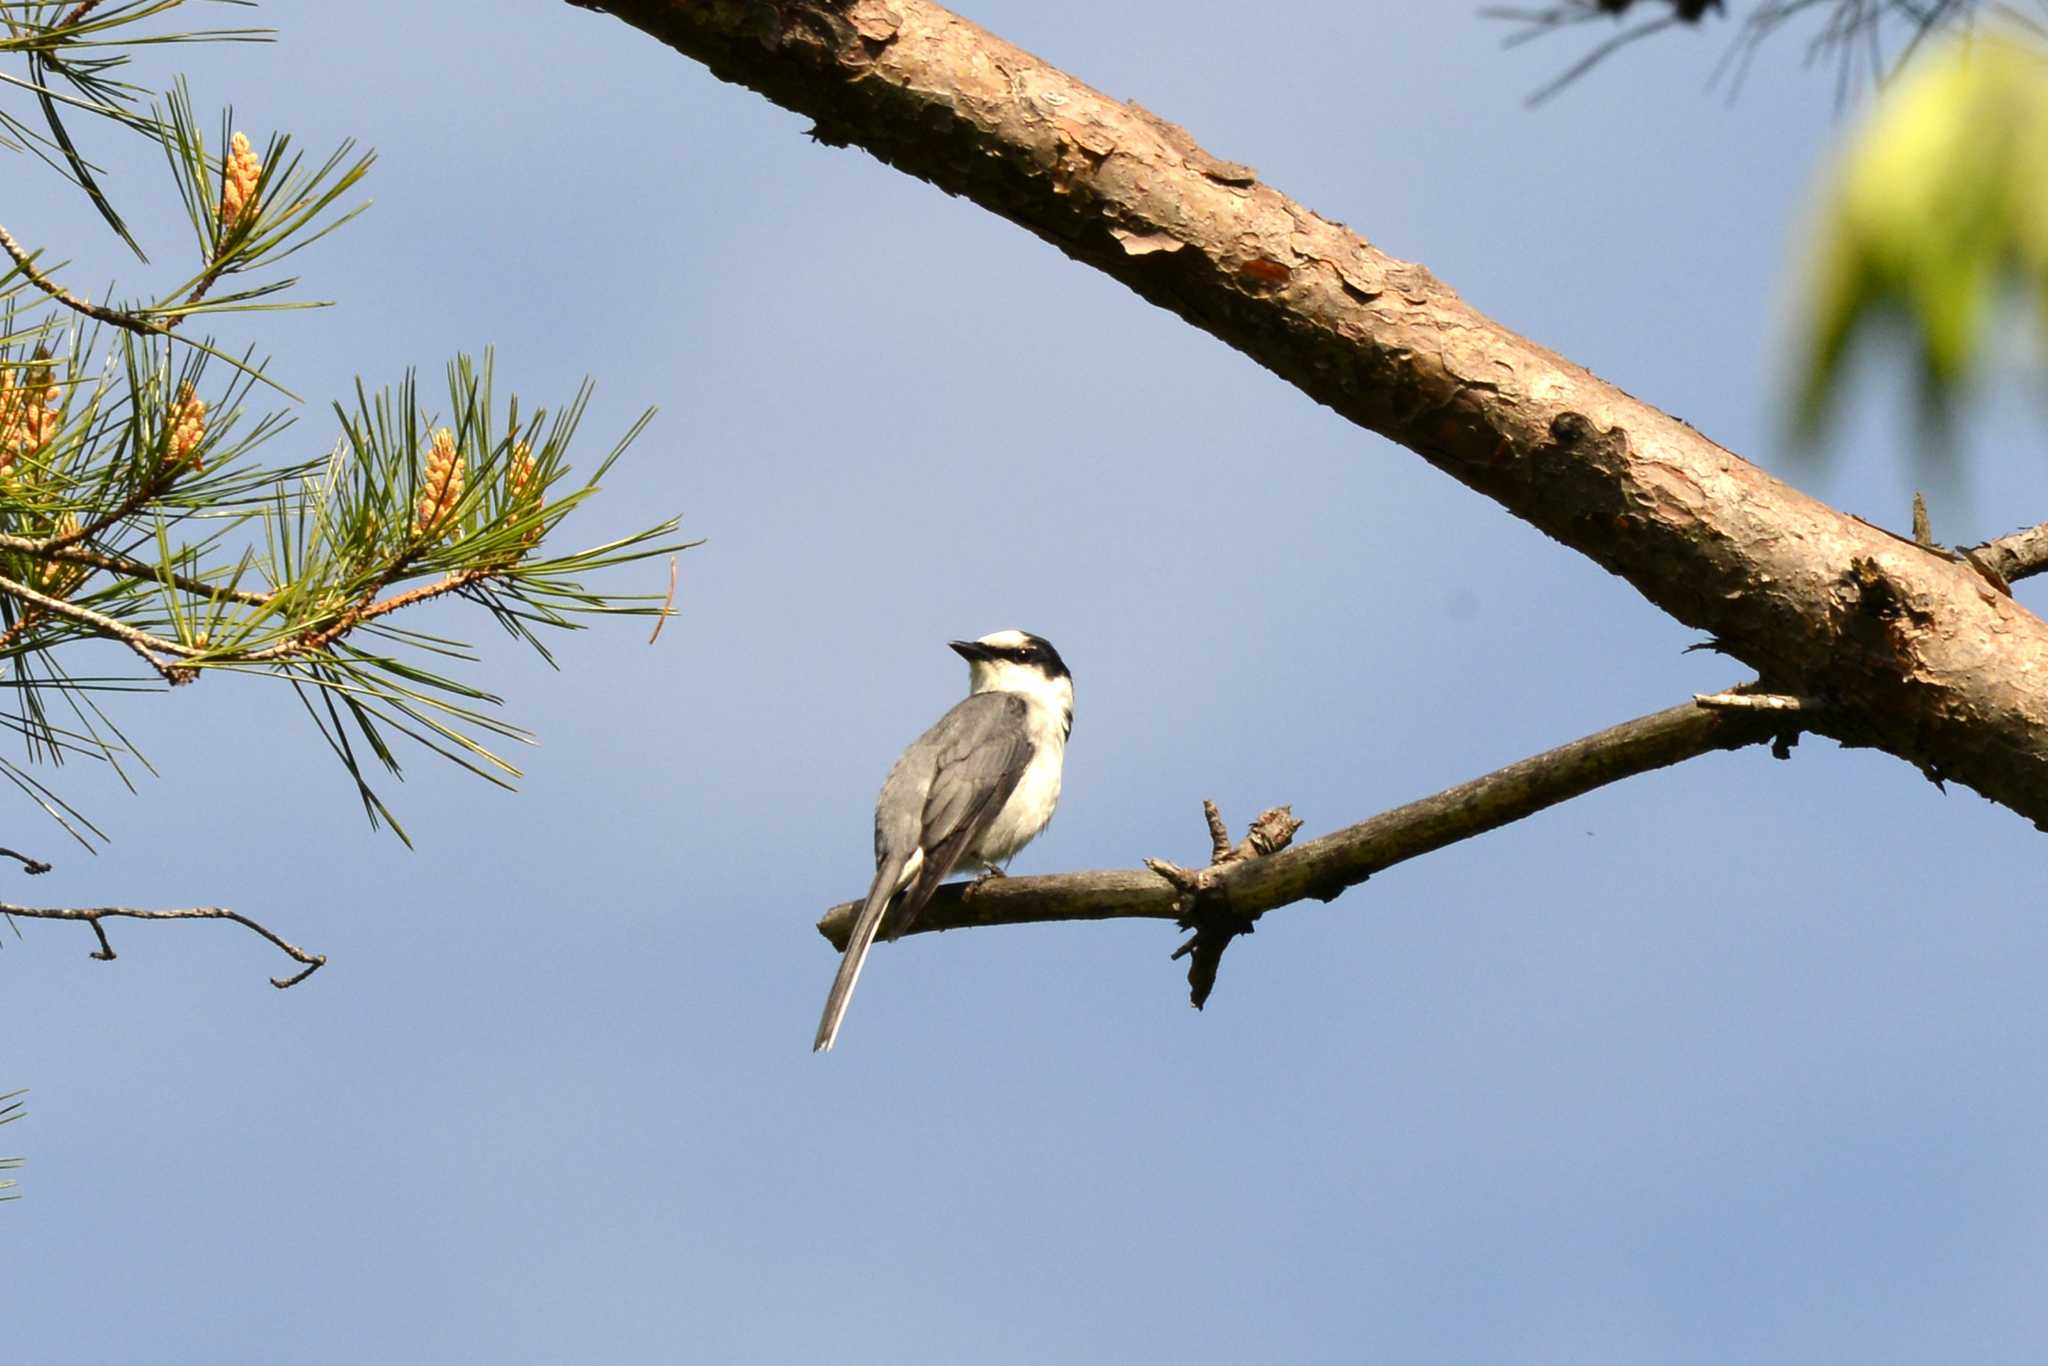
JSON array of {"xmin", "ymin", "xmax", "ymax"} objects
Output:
[{"xmin": 874, "ymin": 692, "xmax": 1034, "ymax": 940}]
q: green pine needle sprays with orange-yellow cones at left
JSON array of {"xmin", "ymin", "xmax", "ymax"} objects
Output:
[{"xmin": 0, "ymin": 0, "xmax": 690, "ymax": 843}]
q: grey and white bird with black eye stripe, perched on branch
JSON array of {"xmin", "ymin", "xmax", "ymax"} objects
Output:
[{"xmin": 813, "ymin": 631, "xmax": 1073, "ymax": 1053}]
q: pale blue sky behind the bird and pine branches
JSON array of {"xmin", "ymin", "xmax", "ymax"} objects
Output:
[{"xmin": 0, "ymin": 0, "xmax": 2048, "ymax": 1364}]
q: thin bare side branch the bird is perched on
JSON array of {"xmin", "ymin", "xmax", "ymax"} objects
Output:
[{"xmin": 817, "ymin": 688, "xmax": 1812, "ymax": 966}]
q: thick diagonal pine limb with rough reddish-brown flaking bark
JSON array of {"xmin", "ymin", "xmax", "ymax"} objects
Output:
[{"xmin": 571, "ymin": 0, "xmax": 2048, "ymax": 829}]
